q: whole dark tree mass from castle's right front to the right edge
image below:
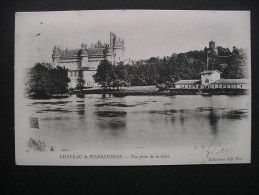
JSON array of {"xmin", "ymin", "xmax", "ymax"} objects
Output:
[{"xmin": 94, "ymin": 47, "xmax": 248, "ymax": 89}]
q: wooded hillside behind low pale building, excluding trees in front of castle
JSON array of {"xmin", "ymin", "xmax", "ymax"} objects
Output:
[{"xmin": 126, "ymin": 47, "xmax": 247, "ymax": 85}]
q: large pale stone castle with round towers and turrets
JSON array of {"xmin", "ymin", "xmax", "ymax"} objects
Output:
[{"xmin": 52, "ymin": 32, "xmax": 125, "ymax": 88}]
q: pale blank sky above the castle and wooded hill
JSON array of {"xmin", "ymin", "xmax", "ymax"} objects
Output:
[{"xmin": 15, "ymin": 10, "xmax": 250, "ymax": 66}]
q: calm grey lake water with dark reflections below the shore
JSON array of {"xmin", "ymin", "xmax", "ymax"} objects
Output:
[{"xmin": 26, "ymin": 95, "xmax": 249, "ymax": 151}]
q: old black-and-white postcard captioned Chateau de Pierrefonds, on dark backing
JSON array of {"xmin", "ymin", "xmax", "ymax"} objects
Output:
[{"xmin": 14, "ymin": 10, "xmax": 251, "ymax": 166}]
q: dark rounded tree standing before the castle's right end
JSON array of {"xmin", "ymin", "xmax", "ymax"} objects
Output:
[{"xmin": 93, "ymin": 59, "xmax": 116, "ymax": 89}]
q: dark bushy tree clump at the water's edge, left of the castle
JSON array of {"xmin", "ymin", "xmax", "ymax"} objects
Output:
[{"xmin": 27, "ymin": 63, "xmax": 70, "ymax": 97}]
